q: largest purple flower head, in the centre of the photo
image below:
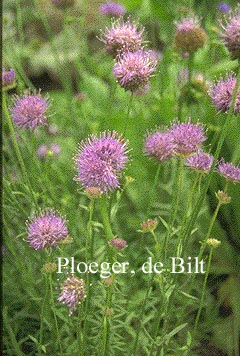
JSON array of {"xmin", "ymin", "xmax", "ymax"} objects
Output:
[{"xmin": 74, "ymin": 131, "xmax": 128, "ymax": 193}]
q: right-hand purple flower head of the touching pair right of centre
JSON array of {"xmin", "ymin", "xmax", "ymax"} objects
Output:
[{"xmin": 170, "ymin": 121, "xmax": 207, "ymax": 157}]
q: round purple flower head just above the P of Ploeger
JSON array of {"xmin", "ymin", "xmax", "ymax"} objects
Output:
[{"xmin": 27, "ymin": 209, "xmax": 68, "ymax": 250}]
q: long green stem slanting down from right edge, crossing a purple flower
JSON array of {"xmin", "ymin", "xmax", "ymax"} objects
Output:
[{"xmin": 184, "ymin": 69, "xmax": 240, "ymax": 243}]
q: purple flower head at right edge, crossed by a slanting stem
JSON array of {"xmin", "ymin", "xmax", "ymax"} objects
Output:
[{"xmin": 208, "ymin": 73, "xmax": 240, "ymax": 114}]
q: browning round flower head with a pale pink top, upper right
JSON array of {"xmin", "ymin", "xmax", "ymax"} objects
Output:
[{"xmin": 174, "ymin": 18, "xmax": 207, "ymax": 53}]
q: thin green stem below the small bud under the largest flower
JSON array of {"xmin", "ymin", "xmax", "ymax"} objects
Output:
[{"xmin": 82, "ymin": 199, "xmax": 94, "ymax": 353}]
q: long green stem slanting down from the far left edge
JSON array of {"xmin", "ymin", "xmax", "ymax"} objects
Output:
[{"xmin": 3, "ymin": 95, "xmax": 38, "ymax": 208}]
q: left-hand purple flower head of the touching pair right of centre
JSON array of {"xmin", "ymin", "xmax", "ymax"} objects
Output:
[{"xmin": 143, "ymin": 131, "xmax": 174, "ymax": 162}]
